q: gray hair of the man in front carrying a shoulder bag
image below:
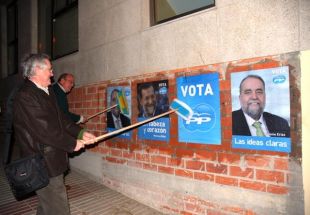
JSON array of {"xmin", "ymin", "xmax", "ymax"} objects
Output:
[{"xmin": 21, "ymin": 54, "xmax": 50, "ymax": 79}]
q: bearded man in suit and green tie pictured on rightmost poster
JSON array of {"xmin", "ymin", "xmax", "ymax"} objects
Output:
[{"xmin": 232, "ymin": 75, "xmax": 290, "ymax": 137}]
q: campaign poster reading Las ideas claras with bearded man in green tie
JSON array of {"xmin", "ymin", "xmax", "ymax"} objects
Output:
[{"xmin": 231, "ymin": 66, "xmax": 291, "ymax": 153}]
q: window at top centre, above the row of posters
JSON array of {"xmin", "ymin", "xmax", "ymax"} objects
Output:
[{"xmin": 153, "ymin": 0, "xmax": 215, "ymax": 25}]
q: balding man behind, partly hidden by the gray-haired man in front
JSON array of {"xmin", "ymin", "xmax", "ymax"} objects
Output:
[{"xmin": 53, "ymin": 73, "xmax": 86, "ymax": 124}]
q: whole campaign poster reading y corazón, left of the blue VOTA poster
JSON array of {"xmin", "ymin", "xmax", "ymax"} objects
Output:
[{"xmin": 137, "ymin": 80, "xmax": 170, "ymax": 141}]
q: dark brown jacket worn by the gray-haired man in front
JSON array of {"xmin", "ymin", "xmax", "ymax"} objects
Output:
[{"xmin": 13, "ymin": 80, "xmax": 82, "ymax": 177}]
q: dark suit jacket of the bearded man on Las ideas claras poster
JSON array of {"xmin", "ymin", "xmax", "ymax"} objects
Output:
[{"xmin": 232, "ymin": 109, "xmax": 290, "ymax": 137}]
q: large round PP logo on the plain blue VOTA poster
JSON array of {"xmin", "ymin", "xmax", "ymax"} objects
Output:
[{"xmin": 183, "ymin": 104, "xmax": 216, "ymax": 132}]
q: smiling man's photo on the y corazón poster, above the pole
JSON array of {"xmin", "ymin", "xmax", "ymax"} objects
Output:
[{"xmin": 138, "ymin": 80, "xmax": 169, "ymax": 118}]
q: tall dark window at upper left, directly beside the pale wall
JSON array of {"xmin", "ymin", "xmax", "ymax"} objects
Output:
[{"xmin": 52, "ymin": 0, "xmax": 79, "ymax": 59}]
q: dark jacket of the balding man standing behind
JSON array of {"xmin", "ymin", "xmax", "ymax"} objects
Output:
[{"xmin": 53, "ymin": 83, "xmax": 81, "ymax": 123}]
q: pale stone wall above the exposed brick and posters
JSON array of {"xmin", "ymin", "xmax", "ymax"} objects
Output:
[{"xmin": 54, "ymin": 0, "xmax": 310, "ymax": 86}]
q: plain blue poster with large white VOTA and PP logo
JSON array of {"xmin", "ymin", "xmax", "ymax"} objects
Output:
[{"xmin": 177, "ymin": 73, "xmax": 221, "ymax": 145}]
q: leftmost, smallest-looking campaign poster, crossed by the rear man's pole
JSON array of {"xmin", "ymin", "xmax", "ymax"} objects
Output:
[{"xmin": 106, "ymin": 86, "xmax": 132, "ymax": 139}]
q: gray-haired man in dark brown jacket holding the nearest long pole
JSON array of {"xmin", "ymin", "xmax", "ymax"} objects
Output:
[{"xmin": 13, "ymin": 54, "xmax": 95, "ymax": 215}]
